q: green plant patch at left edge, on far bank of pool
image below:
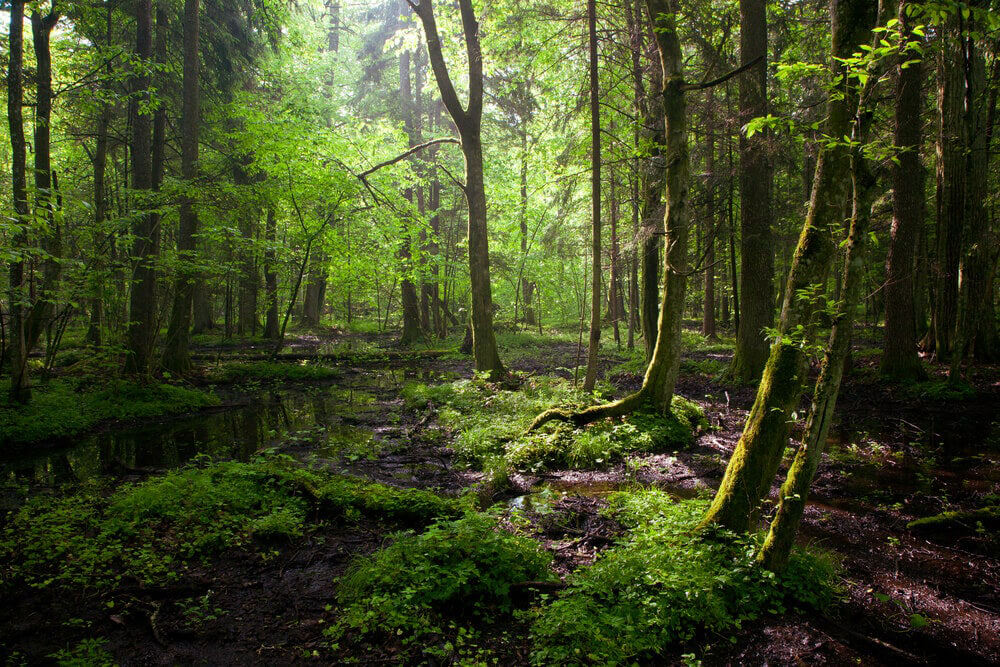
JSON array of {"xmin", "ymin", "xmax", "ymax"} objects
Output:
[{"xmin": 0, "ymin": 378, "xmax": 219, "ymax": 445}]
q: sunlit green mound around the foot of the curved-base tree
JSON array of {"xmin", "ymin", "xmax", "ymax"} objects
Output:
[{"xmin": 403, "ymin": 377, "xmax": 705, "ymax": 472}]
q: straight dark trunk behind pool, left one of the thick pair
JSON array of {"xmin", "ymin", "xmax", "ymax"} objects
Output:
[{"xmin": 125, "ymin": 0, "xmax": 157, "ymax": 375}]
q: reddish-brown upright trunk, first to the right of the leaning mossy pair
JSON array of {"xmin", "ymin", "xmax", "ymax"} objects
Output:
[{"xmin": 880, "ymin": 2, "xmax": 925, "ymax": 381}]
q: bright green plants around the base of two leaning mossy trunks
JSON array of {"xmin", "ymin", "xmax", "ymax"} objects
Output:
[{"xmin": 532, "ymin": 491, "xmax": 835, "ymax": 665}]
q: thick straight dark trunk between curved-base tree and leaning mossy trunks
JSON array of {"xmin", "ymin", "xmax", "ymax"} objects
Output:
[{"xmin": 730, "ymin": 0, "xmax": 776, "ymax": 383}]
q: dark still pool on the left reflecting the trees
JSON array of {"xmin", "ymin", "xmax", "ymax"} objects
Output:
[{"xmin": 0, "ymin": 369, "xmax": 458, "ymax": 486}]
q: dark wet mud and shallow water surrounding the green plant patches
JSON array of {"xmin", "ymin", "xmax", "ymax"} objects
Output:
[{"xmin": 0, "ymin": 337, "xmax": 1000, "ymax": 665}]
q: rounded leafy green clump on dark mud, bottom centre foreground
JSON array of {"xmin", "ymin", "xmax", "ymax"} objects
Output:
[{"xmin": 327, "ymin": 513, "xmax": 552, "ymax": 650}]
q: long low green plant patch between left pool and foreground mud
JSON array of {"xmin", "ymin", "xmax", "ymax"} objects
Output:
[{"xmin": 0, "ymin": 456, "xmax": 459, "ymax": 588}]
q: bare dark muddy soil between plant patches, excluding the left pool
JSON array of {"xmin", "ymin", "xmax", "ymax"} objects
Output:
[{"xmin": 0, "ymin": 326, "xmax": 1000, "ymax": 665}]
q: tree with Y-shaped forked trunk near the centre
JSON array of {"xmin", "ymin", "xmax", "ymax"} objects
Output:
[{"xmin": 407, "ymin": 0, "xmax": 507, "ymax": 379}]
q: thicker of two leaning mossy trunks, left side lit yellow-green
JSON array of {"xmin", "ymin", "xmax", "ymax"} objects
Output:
[{"xmin": 701, "ymin": 0, "xmax": 876, "ymax": 532}]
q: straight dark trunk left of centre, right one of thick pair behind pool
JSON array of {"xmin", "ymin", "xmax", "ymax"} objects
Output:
[{"xmin": 163, "ymin": 0, "xmax": 201, "ymax": 373}]
